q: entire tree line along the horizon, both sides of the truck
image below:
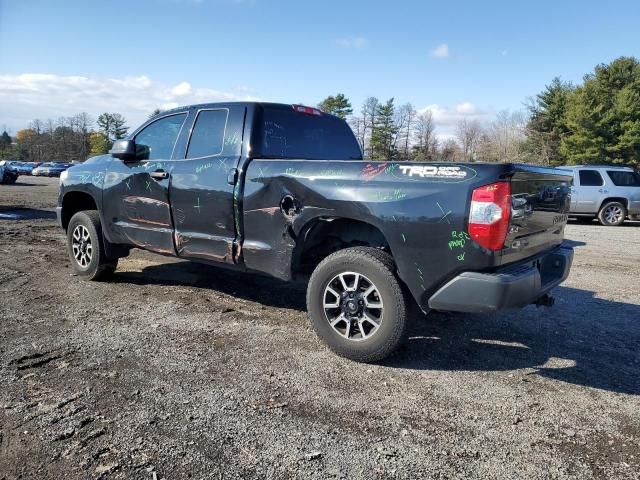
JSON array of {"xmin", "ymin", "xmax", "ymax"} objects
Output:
[{"xmin": 0, "ymin": 57, "xmax": 640, "ymax": 166}]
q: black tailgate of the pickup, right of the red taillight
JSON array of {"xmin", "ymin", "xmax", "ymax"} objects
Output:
[{"xmin": 500, "ymin": 166, "xmax": 572, "ymax": 264}]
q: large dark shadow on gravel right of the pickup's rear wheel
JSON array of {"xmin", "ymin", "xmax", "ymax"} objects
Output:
[{"xmin": 383, "ymin": 287, "xmax": 640, "ymax": 395}]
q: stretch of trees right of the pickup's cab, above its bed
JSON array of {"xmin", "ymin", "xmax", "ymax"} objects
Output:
[{"xmin": 318, "ymin": 57, "xmax": 640, "ymax": 166}]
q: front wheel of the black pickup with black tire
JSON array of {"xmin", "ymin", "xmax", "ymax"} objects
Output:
[{"xmin": 67, "ymin": 210, "xmax": 118, "ymax": 280}]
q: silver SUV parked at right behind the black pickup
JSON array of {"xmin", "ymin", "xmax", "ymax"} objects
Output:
[{"xmin": 559, "ymin": 165, "xmax": 640, "ymax": 226}]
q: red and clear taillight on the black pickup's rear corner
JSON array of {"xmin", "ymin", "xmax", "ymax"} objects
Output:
[{"xmin": 469, "ymin": 182, "xmax": 511, "ymax": 250}]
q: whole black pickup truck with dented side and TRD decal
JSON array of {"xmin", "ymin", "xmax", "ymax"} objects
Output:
[{"xmin": 57, "ymin": 102, "xmax": 573, "ymax": 361}]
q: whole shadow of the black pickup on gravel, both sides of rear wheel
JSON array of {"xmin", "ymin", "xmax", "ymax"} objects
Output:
[{"xmin": 113, "ymin": 262, "xmax": 640, "ymax": 395}]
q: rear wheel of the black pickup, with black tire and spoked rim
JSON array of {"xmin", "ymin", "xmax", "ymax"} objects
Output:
[{"xmin": 307, "ymin": 247, "xmax": 407, "ymax": 362}]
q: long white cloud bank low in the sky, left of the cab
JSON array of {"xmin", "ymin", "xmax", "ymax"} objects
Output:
[{"xmin": 0, "ymin": 73, "xmax": 256, "ymax": 133}]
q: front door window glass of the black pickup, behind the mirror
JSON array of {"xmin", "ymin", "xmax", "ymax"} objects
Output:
[{"xmin": 135, "ymin": 113, "xmax": 187, "ymax": 160}]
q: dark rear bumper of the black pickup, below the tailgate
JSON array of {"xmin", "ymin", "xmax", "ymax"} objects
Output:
[{"xmin": 429, "ymin": 247, "xmax": 573, "ymax": 313}]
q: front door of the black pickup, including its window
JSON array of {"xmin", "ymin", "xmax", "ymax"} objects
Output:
[{"xmin": 103, "ymin": 111, "xmax": 188, "ymax": 255}]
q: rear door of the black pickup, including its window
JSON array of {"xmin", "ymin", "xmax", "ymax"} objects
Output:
[{"xmin": 170, "ymin": 105, "xmax": 245, "ymax": 263}]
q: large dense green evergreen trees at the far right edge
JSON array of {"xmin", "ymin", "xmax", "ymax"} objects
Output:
[{"xmin": 561, "ymin": 57, "xmax": 640, "ymax": 166}]
